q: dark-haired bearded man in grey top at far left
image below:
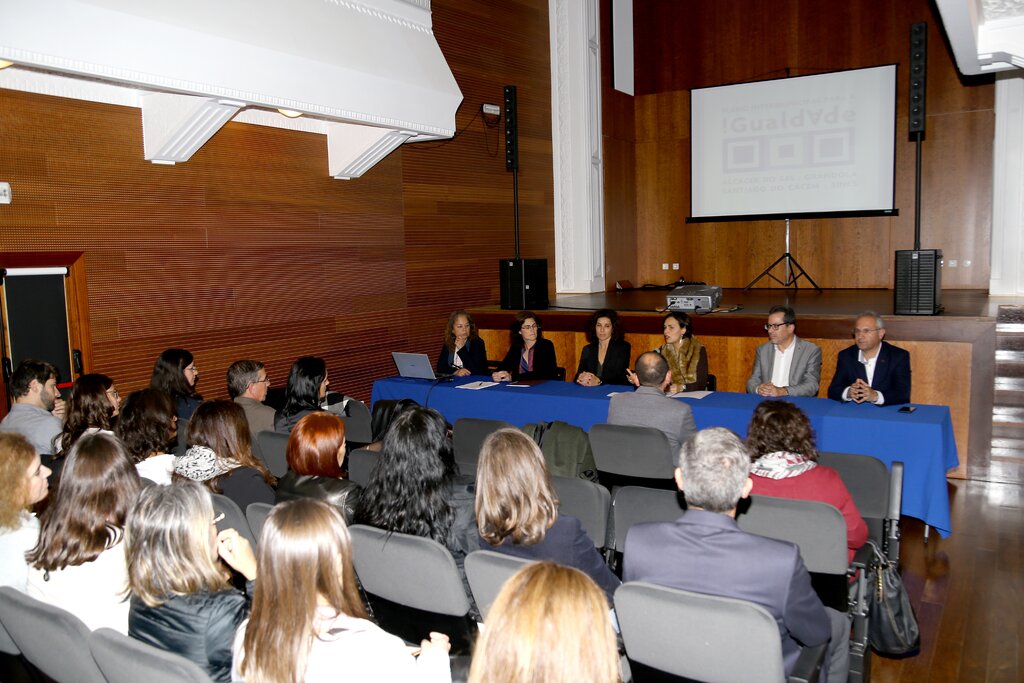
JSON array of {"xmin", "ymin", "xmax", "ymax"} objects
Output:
[{"xmin": 0, "ymin": 358, "xmax": 65, "ymax": 464}]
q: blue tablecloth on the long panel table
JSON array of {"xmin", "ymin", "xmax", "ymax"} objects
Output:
[{"xmin": 373, "ymin": 377, "xmax": 959, "ymax": 537}]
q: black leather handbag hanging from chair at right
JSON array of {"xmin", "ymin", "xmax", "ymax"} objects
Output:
[{"xmin": 867, "ymin": 541, "xmax": 921, "ymax": 656}]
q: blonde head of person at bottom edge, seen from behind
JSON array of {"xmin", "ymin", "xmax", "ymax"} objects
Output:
[{"xmin": 469, "ymin": 562, "xmax": 622, "ymax": 683}]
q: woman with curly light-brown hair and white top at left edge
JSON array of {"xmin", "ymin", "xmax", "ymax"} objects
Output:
[{"xmin": 0, "ymin": 433, "xmax": 50, "ymax": 593}]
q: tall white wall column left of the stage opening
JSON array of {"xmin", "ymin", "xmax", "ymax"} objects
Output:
[{"xmin": 548, "ymin": 0, "xmax": 604, "ymax": 293}]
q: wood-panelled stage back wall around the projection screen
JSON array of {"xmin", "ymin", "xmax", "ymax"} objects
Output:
[{"xmin": 602, "ymin": 0, "xmax": 994, "ymax": 289}]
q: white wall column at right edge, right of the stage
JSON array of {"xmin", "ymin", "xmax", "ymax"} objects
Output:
[{"xmin": 988, "ymin": 69, "xmax": 1024, "ymax": 296}]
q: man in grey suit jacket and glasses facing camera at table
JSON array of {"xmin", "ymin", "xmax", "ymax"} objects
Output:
[{"xmin": 746, "ymin": 306, "xmax": 821, "ymax": 396}]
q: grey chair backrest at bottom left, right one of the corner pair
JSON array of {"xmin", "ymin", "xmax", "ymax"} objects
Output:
[{"xmin": 89, "ymin": 629, "xmax": 210, "ymax": 683}]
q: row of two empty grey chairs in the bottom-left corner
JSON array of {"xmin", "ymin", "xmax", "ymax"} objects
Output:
[{"xmin": 0, "ymin": 587, "xmax": 210, "ymax": 683}]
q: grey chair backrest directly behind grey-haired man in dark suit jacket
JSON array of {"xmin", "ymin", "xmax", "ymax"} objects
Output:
[{"xmin": 614, "ymin": 582, "xmax": 785, "ymax": 683}]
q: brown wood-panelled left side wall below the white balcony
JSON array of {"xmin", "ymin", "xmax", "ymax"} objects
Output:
[{"xmin": 0, "ymin": 0, "xmax": 554, "ymax": 399}]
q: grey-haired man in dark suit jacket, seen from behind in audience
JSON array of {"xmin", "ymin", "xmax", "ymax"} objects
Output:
[{"xmin": 623, "ymin": 427, "xmax": 850, "ymax": 683}]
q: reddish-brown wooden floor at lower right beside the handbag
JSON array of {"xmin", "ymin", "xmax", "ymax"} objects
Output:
[{"xmin": 871, "ymin": 480, "xmax": 1024, "ymax": 683}]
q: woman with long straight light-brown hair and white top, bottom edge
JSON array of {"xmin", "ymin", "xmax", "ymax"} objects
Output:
[{"xmin": 232, "ymin": 499, "xmax": 452, "ymax": 683}]
